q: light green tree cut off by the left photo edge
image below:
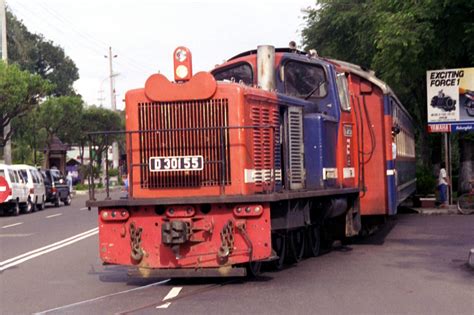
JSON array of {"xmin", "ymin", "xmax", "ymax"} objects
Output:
[{"xmin": 0, "ymin": 61, "xmax": 52, "ymax": 147}]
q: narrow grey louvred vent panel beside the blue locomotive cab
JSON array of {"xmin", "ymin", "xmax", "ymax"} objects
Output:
[{"xmin": 288, "ymin": 107, "xmax": 305, "ymax": 190}]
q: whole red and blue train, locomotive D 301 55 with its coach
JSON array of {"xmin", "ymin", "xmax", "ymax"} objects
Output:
[{"xmin": 87, "ymin": 46, "xmax": 415, "ymax": 277}]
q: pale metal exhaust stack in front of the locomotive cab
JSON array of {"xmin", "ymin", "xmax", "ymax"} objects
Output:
[{"xmin": 257, "ymin": 45, "xmax": 276, "ymax": 91}]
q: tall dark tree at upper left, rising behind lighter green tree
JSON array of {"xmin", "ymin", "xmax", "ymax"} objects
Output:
[{"xmin": 7, "ymin": 11, "xmax": 79, "ymax": 96}]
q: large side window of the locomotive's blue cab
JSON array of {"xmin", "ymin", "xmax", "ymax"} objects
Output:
[{"xmin": 284, "ymin": 61, "xmax": 327, "ymax": 100}]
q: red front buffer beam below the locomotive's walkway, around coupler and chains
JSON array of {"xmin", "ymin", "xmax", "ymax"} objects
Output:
[{"xmin": 99, "ymin": 204, "xmax": 271, "ymax": 268}]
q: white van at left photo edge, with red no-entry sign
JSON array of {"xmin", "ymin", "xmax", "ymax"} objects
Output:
[{"xmin": 0, "ymin": 164, "xmax": 33, "ymax": 215}]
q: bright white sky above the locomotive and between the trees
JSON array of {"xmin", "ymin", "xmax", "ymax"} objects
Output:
[{"xmin": 6, "ymin": 0, "xmax": 315, "ymax": 109}]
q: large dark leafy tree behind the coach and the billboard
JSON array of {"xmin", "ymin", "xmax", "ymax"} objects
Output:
[{"xmin": 302, "ymin": 0, "xmax": 474, "ymax": 193}]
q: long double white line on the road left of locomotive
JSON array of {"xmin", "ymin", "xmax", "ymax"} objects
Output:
[{"xmin": 0, "ymin": 228, "xmax": 99, "ymax": 271}]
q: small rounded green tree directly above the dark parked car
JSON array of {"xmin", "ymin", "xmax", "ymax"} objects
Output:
[{"xmin": 35, "ymin": 96, "xmax": 84, "ymax": 160}]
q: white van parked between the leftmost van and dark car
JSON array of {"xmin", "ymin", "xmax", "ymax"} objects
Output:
[{"xmin": 12, "ymin": 164, "xmax": 46, "ymax": 211}]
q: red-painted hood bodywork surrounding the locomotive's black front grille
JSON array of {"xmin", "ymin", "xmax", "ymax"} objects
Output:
[{"xmin": 126, "ymin": 81, "xmax": 278, "ymax": 198}]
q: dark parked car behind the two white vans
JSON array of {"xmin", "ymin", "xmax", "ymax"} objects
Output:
[{"xmin": 41, "ymin": 169, "xmax": 72, "ymax": 207}]
